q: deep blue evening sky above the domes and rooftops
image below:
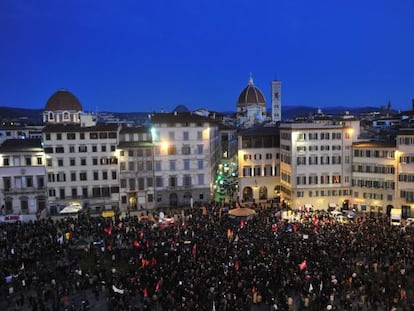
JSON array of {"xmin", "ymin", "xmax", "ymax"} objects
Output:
[{"xmin": 0, "ymin": 0, "xmax": 414, "ymax": 112}]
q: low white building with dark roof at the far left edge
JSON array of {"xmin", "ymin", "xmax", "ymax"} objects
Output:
[{"xmin": 0, "ymin": 139, "xmax": 47, "ymax": 215}]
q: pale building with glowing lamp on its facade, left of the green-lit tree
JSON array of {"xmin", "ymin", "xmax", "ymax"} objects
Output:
[{"xmin": 150, "ymin": 112, "xmax": 221, "ymax": 207}]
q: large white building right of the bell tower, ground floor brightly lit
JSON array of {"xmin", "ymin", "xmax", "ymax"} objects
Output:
[{"xmin": 280, "ymin": 120, "xmax": 359, "ymax": 209}]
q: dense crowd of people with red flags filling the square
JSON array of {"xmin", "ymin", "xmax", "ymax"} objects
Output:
[{"xmin": 0, "ymin": 205, "xmax": 414, "ymax": 311}]
